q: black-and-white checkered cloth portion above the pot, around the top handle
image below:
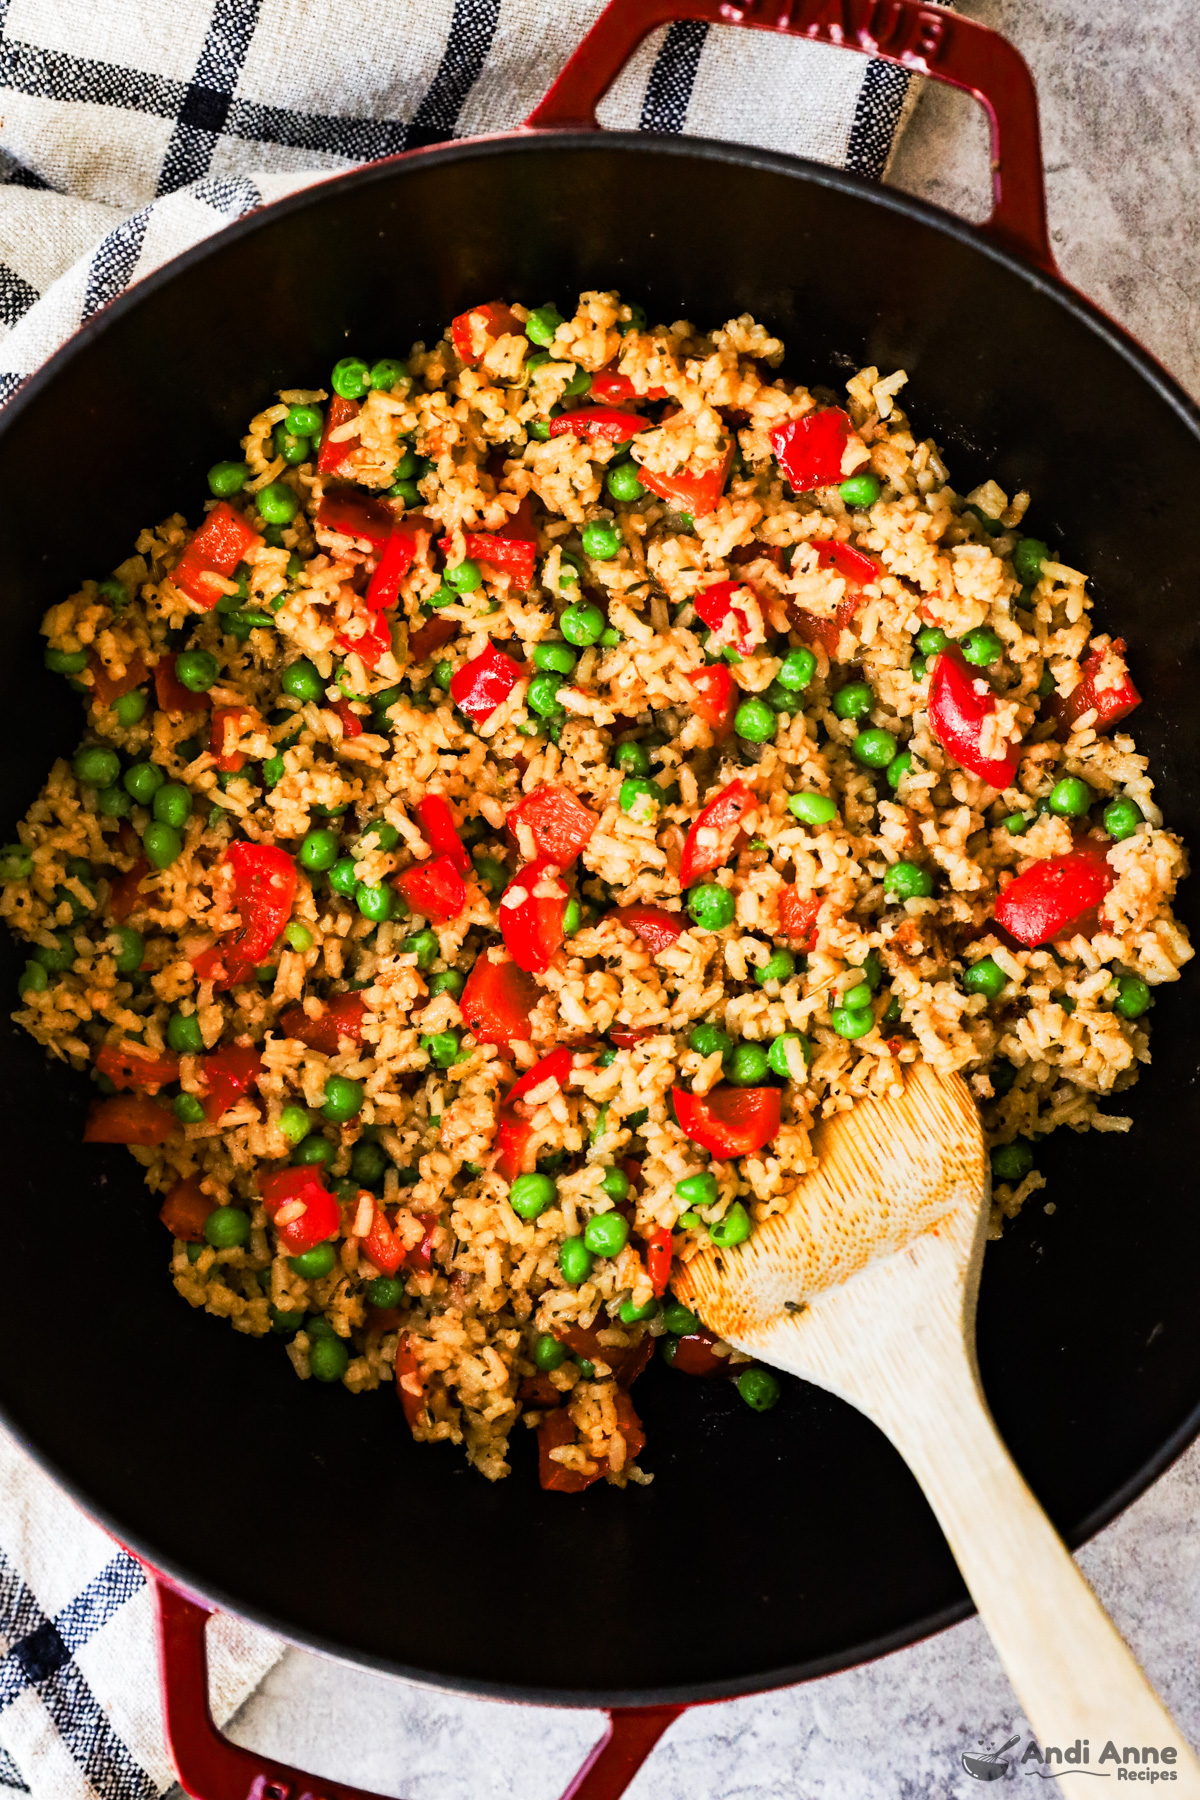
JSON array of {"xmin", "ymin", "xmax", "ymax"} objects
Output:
[{"xmin": 0, "ymin": 0, "xmax": 914, "ymax": 403}]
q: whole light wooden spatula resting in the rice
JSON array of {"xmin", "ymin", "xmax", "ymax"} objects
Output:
[{"xmin": 675, "ymin": 1064, "xmax": 1200, "ymax": 1778}]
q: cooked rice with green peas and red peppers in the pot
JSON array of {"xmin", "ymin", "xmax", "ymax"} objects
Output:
[{"xmin": 0, "ymin": 293, "xmax": 1193, "ymax": 1490}]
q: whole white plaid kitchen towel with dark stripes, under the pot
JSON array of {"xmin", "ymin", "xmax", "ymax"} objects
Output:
[{"xmin": 0, "ymin": 0, "xmax": 914, "ymax": 1800}]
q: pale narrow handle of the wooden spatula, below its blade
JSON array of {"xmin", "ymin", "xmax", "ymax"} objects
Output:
[{"xmin": 858, "ymin": 1330, "xmax": 1200, "ymax": 1778}]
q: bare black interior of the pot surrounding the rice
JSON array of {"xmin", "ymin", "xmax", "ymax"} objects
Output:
[{"xmin": 0, "ymin": 137, "xmax": 1200, "ymax": 1697}]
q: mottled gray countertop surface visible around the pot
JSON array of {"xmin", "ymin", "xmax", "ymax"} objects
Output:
[{"xmin": 197, "ymin": 0, "xmax": 1200, "ymax": 1800}]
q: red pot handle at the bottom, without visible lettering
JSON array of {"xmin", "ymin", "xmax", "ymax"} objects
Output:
[{"xmin": 146, "ymin": 1568, "xmax": 684, "ymax": 1800}]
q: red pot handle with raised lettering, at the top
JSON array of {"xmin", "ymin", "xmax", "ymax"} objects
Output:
[{"xmin": 525, "ymin": 0, "xmax": 1058, "ymax": 275}]
